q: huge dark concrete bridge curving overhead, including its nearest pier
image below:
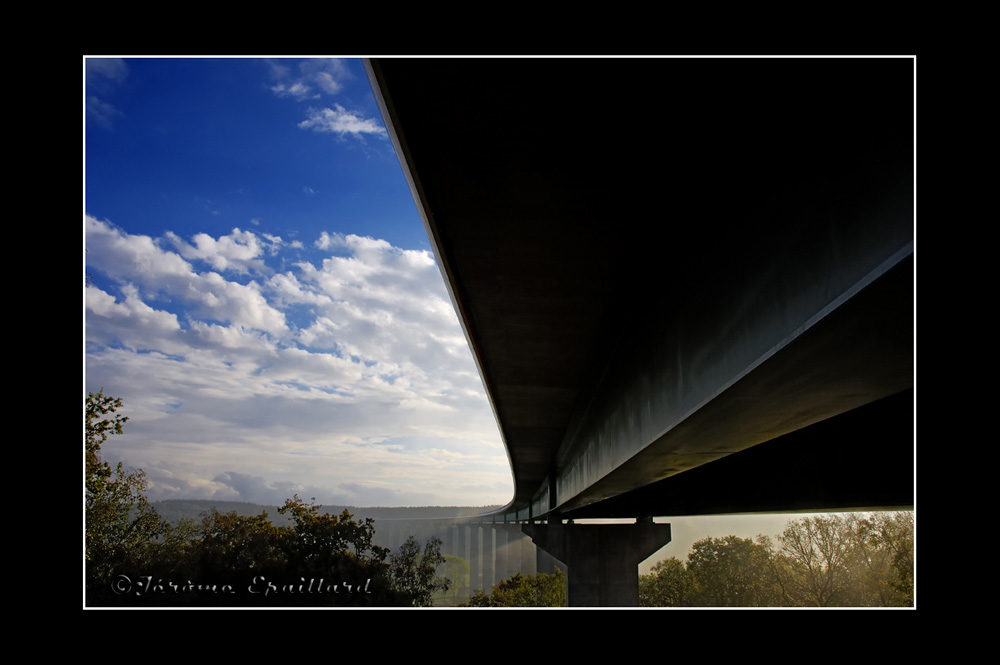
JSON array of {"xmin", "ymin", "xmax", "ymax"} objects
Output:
[{"xmin": 367, "ymin": 58, "xmax": 915, "ymax": 605}]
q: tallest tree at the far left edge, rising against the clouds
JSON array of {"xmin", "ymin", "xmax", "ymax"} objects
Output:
[{"xmin": 84, "ymin": 390, "xmax": 165, "ymax": 594}]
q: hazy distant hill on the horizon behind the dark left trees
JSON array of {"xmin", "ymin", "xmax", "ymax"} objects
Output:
[{"xmin": 151, "ymin": 499, "xmax": 503, "ymax": 526}]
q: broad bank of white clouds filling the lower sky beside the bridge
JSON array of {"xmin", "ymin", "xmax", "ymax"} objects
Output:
[{"xmin": 86, "ymin": 217, "xmax": 509, "ymax": 505}]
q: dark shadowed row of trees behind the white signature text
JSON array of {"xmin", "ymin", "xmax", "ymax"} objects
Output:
[{"xmin": 85, "ymin": 391, "xmax": 448, "ymax": 607}]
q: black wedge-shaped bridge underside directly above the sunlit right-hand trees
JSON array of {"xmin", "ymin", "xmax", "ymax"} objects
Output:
[{"xmin": 564, "ymin": 390, "xmax": 914, "ymax": 519}]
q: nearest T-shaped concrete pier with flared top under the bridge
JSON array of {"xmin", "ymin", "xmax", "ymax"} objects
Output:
[{"xmin": 521, "ymin": 517, "xmax": 670, "ymax": 607}]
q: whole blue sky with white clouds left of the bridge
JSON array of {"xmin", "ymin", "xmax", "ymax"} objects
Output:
[{"xmin": 84, "ymin": 58, "xmax": 513, "ymax": 506}]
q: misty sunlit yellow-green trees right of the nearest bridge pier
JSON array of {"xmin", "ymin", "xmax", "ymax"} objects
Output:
[{"xmin": 639, "ymin": 512, "xmax": 915, "ymax": 607}]
